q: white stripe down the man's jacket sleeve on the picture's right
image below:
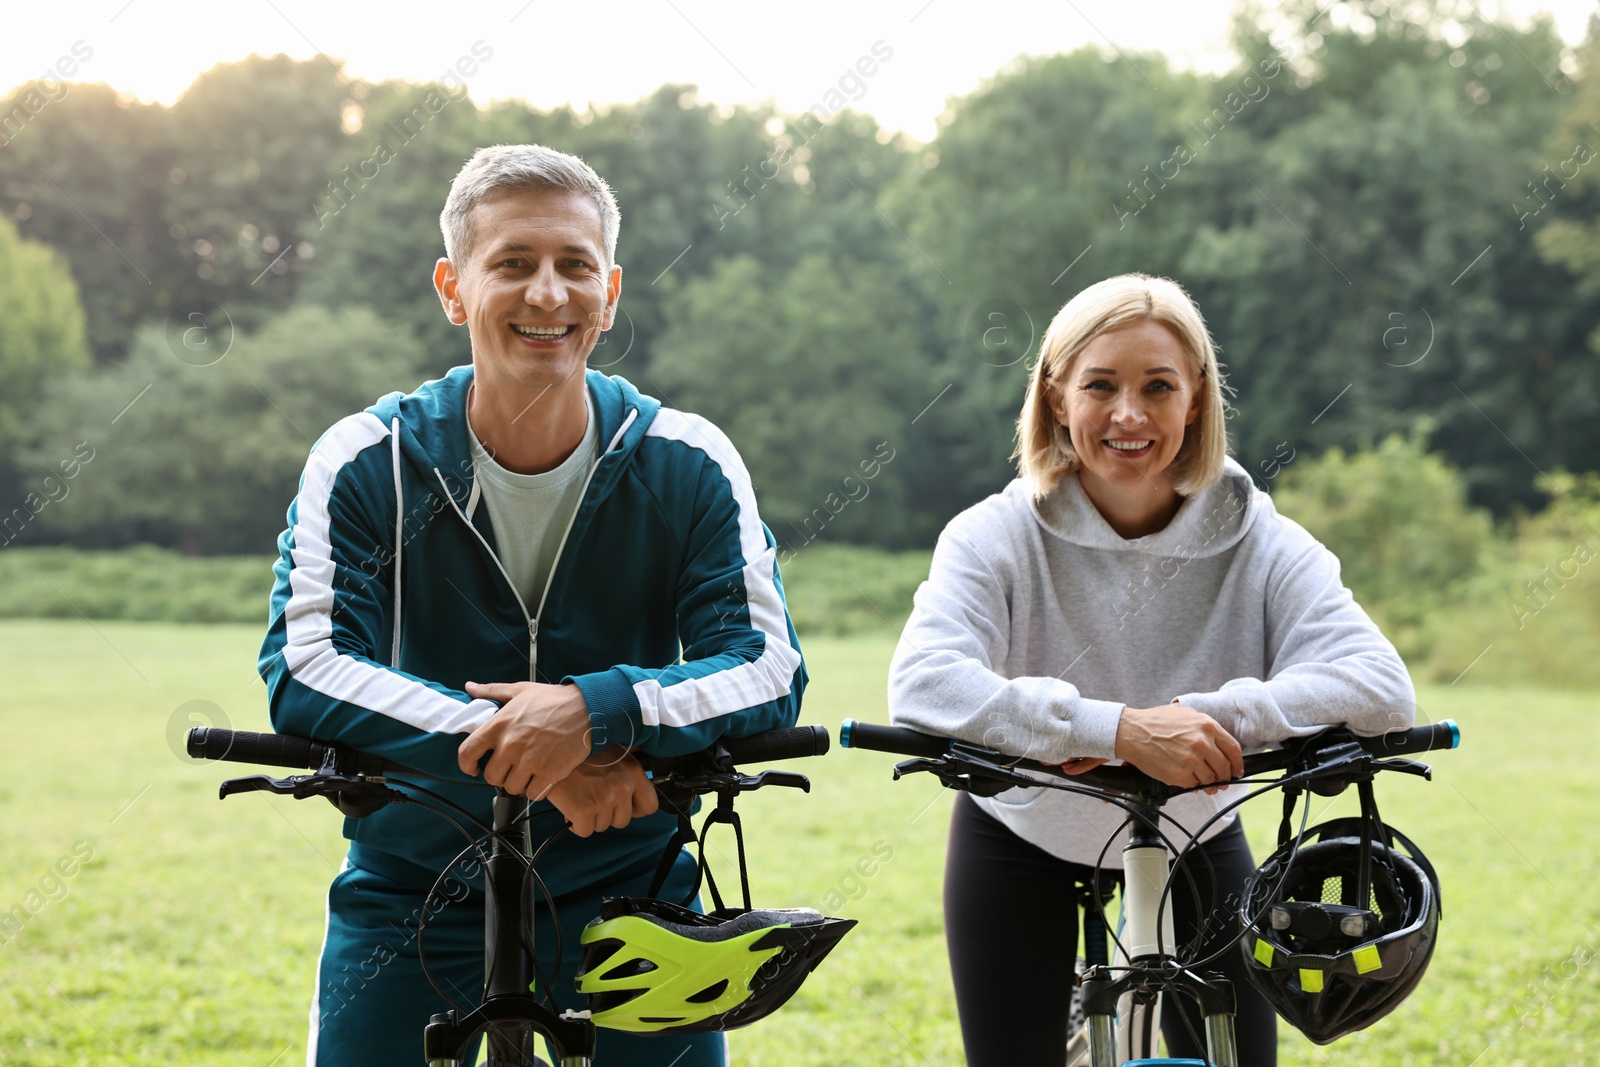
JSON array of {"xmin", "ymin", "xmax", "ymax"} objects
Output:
[{"xmin": 634, "ymin": 408, "xmax": 800, "ymax": 726}]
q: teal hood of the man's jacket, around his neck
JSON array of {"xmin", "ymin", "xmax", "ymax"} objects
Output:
[{"xmin": 368, "ymin": 365, "xmax": 661, "ymax": 509}]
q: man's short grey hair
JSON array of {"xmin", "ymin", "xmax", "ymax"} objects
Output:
[{"xmin": 438, "ymin": 144, "xmax": 622, "ymax": 267}]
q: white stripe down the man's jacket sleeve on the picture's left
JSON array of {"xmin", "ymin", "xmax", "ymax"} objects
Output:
[{"xmin": 283, "ymin": 411, "xmax": 499, "ymax": 734}]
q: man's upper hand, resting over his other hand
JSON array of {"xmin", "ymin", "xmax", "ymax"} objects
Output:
[{"xmin": 456, "ymin": 681, "xmax": 592, "ymax": 797}]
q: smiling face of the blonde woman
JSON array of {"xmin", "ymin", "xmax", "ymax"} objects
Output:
[{"xmin": 1050, "ymin": 318, "xmax": 1200, "ymax": 501}]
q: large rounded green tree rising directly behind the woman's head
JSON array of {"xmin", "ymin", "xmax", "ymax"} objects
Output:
[{"xmin": 885, "ymin": 48, "xmax": 1205, "ymax": 517}]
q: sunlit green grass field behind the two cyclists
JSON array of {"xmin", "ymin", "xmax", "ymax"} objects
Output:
[{"xmin": 0, "ymin": 621, "xmax": 1600, "ymax": 1067}]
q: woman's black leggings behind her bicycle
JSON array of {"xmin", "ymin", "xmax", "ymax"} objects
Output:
[{"xmin": 944, "ymin": 793, "xmax": 1277, "ymax": 1067}]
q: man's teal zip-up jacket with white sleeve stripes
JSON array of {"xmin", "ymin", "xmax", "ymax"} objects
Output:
[{"xmin": 258, "ymin": 366, "xmax": 806, "ymax": 896}]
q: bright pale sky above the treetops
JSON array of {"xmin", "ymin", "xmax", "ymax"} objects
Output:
[{"xmin": 0, "ymin": 0, "xmax": 1600, "ymax": 139}]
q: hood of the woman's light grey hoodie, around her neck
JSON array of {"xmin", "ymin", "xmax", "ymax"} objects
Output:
[{"xmin": 1036, "ymin": 456, "xmax": 1272, "ymax": 558}]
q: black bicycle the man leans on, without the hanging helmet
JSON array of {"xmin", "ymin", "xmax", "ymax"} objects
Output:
[{"xmin": 187, "ymin": 726, "xmax": 854, "ymax": 1067}]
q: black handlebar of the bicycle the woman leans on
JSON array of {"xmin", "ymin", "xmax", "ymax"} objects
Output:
[{"xmin": 838, "ymin": 718, "xmax": 1461, "ymax": 792}]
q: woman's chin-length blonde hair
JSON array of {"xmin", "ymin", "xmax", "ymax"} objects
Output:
[{"xmin": 1013, "ymin": 274, "xmax": 1227, "ymax": 498}]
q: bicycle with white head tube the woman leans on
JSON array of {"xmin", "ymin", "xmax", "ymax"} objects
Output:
[{"xmin": 838, "ymin": 720, "xmax": 1461, "ymax": 1067}]
